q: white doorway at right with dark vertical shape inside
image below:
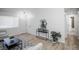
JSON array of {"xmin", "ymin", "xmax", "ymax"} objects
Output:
[{"xmin": 66, "ymin": 14, "xmax": 76, "ymax": 35}]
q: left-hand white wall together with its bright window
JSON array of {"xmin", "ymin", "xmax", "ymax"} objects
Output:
[{"xmin": 0, "ymin": 16, "xmax": 27, "ymax": 36}]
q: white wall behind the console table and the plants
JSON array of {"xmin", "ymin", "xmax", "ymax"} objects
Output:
[{"xmin": 27, "ymin": 8, "xmax": 65, "ymax": 42}]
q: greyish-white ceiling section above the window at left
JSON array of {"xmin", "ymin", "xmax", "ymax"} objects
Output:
[{"xmin": 0, "ymin": 8, "xmax": 32, "ymax": 16}]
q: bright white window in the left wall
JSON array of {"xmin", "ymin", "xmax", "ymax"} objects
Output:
[{"xmin": 0, "ymin": 16, "xmax": 19, "ymax": 29}]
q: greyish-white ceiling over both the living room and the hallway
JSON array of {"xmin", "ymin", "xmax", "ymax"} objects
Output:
[{"xmin": 0, "ymin": 8, "xmax": 79, "ymax": 16}]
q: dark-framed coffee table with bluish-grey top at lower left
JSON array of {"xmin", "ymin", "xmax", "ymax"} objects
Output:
[{"xmin": 3, "ymin": 38, "xmax": 22, "ymax": 50}]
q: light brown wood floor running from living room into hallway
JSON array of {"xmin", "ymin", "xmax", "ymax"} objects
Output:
[{"xmin": 17, "ymin": 33, "xmax": 79, "ymax": 50}]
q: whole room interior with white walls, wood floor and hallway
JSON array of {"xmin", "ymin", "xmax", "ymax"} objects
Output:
[{"xmin": 0, "ymin": 8, "xmax": 79, "ymax": 50}]
